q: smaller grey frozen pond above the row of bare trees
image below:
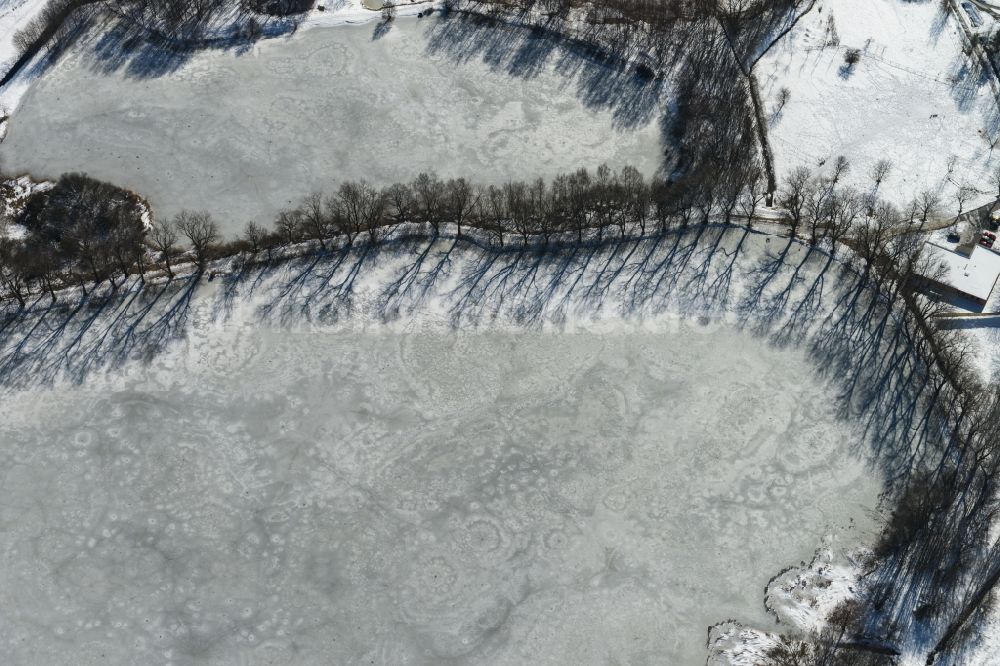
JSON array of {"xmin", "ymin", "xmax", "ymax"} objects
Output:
[{"xmin": 3, "ymin": 18, "xmax": 661, "ymax": 235}]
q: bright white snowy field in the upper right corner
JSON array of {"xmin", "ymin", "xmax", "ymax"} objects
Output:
[{"xmin": 755, "ymin": 0, "xmax": 1000, "ymax": 211}]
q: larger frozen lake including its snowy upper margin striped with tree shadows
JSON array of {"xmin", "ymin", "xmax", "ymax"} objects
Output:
[{"xmin": 0, "ymin": 229, "xmax": 880, "ymax": 665}]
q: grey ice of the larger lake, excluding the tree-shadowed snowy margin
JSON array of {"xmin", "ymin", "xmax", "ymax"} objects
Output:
[{"xmin": 0, "ymin": 310, "xmax": 879, "ymax": 665}]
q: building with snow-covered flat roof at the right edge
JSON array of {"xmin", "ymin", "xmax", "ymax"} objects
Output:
[{"xmin": 922, "ymin": 241, "xmax": 1000, "ymax": 305}]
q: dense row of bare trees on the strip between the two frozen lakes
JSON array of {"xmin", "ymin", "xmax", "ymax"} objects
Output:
[{"xmin": 236, "ymin": 165, "xmax": 764, "ymax": 253}]
